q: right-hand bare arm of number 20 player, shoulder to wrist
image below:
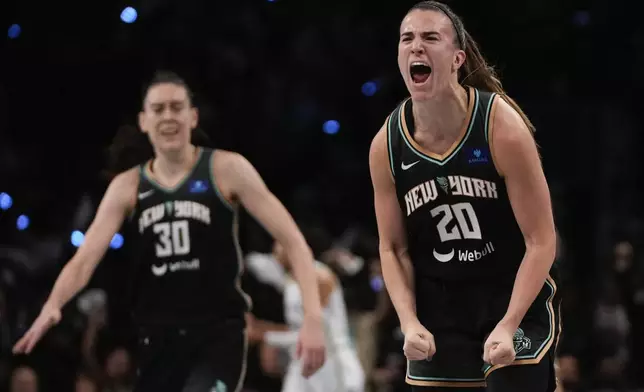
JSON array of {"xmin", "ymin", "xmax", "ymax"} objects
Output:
[{"xmin": 490, "ymin": 98, "xmax": 556, "ymax": 331}]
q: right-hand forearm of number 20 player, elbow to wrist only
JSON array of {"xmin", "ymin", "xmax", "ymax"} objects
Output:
[{"xmin": 501, "ymin": 240, "xmax": 556, "ymax": 331}]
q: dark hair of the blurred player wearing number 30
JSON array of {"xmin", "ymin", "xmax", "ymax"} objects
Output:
[{"xmin": 103, "ymin": 71, "xmax": 210, "ymax": 179}]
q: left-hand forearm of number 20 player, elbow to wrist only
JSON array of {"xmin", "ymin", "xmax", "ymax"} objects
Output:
[{"xmin": 380, "ymin": 251, "xmax": 418, "ymax": 331}]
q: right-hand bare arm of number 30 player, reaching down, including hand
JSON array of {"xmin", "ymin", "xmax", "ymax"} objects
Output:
[{"xmin": 213, "ymin": 150, "xmax": 324, "ymax": 376}]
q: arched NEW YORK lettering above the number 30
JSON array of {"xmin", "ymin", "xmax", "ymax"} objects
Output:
[{"xmin": 139, "ymin": 200, "xmax": 210, "ymax": 233}]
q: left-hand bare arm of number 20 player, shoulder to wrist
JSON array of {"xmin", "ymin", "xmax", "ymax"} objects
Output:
[{"xmin": 369, "ymin": 127, "xmax": 418, "ymax": 331}]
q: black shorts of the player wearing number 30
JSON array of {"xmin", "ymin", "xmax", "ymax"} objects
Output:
[{"xmin": 134, "ymin": 320, "xmax": 247, "ymax": 392}]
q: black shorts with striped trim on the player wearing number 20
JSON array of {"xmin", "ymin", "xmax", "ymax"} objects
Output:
[{"xmin": 406, "ymin": 277, "xmax": 561, "ymax": 392}]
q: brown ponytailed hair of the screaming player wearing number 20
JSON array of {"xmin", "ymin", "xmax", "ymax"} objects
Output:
[{"xmin": 407, "ymin": 1, "xmax": 535, "ymax": 132}]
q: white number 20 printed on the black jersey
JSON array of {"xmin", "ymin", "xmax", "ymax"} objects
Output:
[{"xmin": 430, "ymin": 203, "xmax": 481, "ymax": 242}]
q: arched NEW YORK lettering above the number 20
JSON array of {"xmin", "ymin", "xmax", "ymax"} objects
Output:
[{"xmin": 405, "ymin": 176, "xmax": 499, "ymax": 216}]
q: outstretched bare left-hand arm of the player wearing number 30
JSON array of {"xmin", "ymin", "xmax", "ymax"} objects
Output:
[{"xmin": 14, "ymin": 169, "xmax": 138, "ymax": 353}]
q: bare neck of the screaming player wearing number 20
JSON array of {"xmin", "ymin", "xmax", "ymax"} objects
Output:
[{"xmin": 412, "ymin": 85, "xmax": 468, "ymax": 138}]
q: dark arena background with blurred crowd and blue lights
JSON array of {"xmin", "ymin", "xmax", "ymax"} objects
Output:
[{"xmin": 0, "ymin": 0, "xmax": 644, "ymax": 392}]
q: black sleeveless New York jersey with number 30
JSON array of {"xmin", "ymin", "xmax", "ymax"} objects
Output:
[{"xmin": 130, "ymin": 148, "xmax": 250, "ymax": 325}]
